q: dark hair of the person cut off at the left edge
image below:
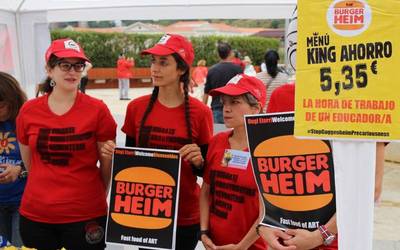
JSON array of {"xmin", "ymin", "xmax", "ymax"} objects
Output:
[{"xmin": 0, "ymin": 72, "xmax": 27, "ymax": 122}]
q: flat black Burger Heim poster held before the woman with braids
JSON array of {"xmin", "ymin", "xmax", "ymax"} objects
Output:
[{"xmin": 106, "ymin": 147, "xmax": 181, "ymax": 249}]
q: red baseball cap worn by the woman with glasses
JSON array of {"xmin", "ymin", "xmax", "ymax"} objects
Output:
[{"xmin": 45, "ymin": 38, "xmax": 90, "ymax": 62}]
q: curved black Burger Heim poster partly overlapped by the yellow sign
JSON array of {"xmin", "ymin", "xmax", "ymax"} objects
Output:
[{"xmin": 245, "ymin": 113, "xmax": 336, "ymax": 231}]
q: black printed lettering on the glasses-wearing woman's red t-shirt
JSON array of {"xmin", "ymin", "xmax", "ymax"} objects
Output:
[{"xmin": 36, "ymin": 127, "xmax": 93, "ymax": 166}]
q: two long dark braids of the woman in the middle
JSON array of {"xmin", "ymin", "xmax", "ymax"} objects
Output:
[{"xmin": 138, "ymin": 53, "xmax": 193, "ymax": 147}]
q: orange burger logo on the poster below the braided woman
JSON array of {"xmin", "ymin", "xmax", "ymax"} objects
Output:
[{"xmin": 110, "ymin": 167, "xmax": 176, "ymax": 229}]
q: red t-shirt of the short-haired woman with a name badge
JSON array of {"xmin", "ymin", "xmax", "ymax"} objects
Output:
[{"xmin": 204, "ymin": 131, "xmax": 267, "ymax": 250}]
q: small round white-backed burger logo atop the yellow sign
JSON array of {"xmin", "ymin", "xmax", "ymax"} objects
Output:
[{"xmin": 327, "ymin": 0, "xmax": 372, "ymax": 37}]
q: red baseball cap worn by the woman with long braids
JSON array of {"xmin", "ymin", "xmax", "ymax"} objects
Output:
[{"xmin": 141, "ymin": 34, "xmax": 194, "ymax": 67}]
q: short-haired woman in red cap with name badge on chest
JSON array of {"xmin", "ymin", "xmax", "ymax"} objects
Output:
[{"xmin": 200, "ymin": 74, "xmax": 266, "ymax": 250}]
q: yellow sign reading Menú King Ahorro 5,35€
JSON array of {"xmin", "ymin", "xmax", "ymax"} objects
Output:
[{"xmin": 295, "ymin": 0, "xmax": 400, "ymax": 141}]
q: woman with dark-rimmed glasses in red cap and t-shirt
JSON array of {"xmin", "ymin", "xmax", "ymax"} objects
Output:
[{"xmin": 16, "ymin": 38, "xmax": 117, "ymax": 250}]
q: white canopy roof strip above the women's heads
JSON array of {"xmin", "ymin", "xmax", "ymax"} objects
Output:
[{"xmin": 0, "ymin": 0, "xmax": 297, "ymax": 19}]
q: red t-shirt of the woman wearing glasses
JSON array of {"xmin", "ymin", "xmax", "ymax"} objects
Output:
[{"xmin": 17, "ymin": 93, "xmax": 116, "ymax": 223}]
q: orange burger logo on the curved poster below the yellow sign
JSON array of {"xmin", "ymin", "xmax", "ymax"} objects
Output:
[{"xmin": 254, "ymin": 135, "xmax": 334, "ymax": 212}]
